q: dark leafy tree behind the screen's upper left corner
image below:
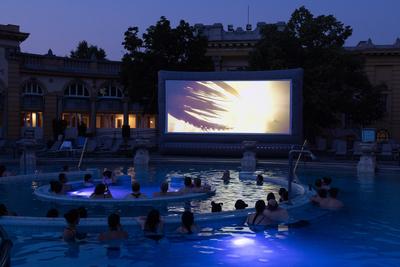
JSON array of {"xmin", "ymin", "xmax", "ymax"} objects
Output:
[{"xmin": 121, "ymin": 17, "xmax": 213, "ymax": 112}]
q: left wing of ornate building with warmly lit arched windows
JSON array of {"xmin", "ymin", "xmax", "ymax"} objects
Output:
[{"xmin": 0, "ymin": 25, "xmax": 156, "ymax": 143}]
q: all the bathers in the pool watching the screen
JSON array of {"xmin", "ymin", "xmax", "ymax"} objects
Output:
[{"xmin": 0, "ymin": 170, "xmax": 343, "ymax": 245}]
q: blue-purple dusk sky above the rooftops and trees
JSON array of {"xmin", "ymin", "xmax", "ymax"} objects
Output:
[{"xmin": 0, "ymin": 0, "xmax": 400, "ymax": 60}]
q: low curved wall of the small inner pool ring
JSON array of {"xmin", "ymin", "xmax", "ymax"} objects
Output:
[{"xmin": 34, "ymin": 182, "xmax": 215, "ymax": 207}]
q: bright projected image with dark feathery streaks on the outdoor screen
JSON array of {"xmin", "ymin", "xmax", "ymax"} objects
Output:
[{"xmin": 165, "ymin": 80, "xmax": 291, "ymax": 134}]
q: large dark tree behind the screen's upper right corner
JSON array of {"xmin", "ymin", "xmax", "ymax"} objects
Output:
[{"xmin": 250, "ymin": 7, "xmax": 383, "ymax": 137}]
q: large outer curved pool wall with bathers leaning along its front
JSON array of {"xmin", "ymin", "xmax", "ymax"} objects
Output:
[{"xmin": 0, "ymin": 173, "xmax": 314, "ymax": 234}]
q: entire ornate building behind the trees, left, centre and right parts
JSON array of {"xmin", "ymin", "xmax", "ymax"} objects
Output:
[{"xmin": 0, "ymin": 22, "xmax": 400, "ymax": 141}]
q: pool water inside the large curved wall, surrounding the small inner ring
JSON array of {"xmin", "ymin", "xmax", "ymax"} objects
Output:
[{"xmin": 0, "ymin": 165, "xmax": 284, "ymax": 217}]
